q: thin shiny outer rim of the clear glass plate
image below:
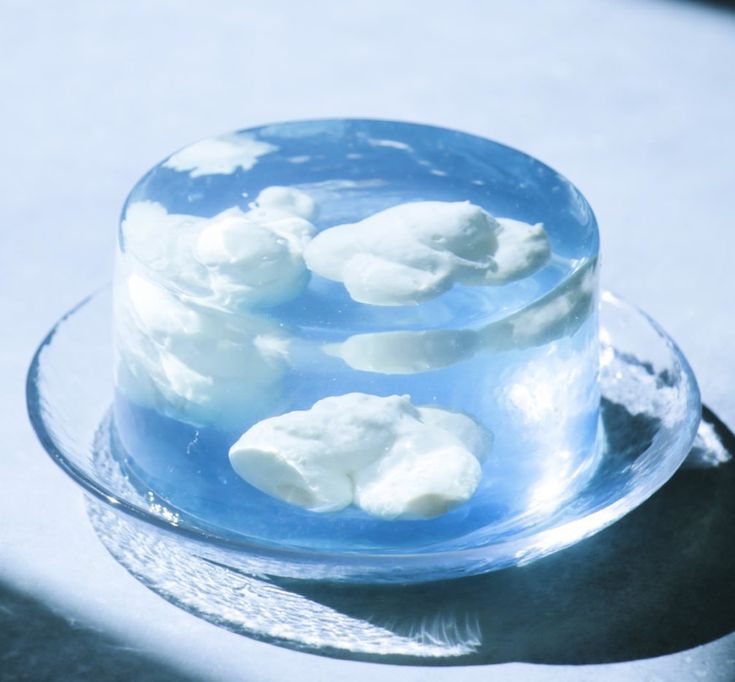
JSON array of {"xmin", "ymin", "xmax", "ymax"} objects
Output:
[{"xmin": 26, "ymin": 284, "xmax": 701, "ymax": 565}]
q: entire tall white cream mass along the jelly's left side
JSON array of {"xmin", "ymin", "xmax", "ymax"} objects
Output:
[{"xmin": 116, "ymin": 186, "xmax": 316, "ymax": 429}]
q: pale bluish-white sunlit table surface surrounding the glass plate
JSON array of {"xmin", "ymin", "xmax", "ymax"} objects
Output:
[{"xmin": 0, "ymin": 0, "xmax": 735, "ymax": 682}]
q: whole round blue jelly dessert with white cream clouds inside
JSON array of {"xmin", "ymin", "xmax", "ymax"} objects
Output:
[{"xmin": 113, "ymin": 120, "xmax": 601, "ymax": 552}]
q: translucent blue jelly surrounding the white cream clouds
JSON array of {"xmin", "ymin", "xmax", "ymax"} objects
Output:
[{"xmin": 114, "ymin": 120, "xmax": 599, "ymax": 551}]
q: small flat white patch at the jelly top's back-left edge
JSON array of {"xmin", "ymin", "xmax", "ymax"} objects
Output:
[{"xmin": 163, "ymin": 133, "xmax": 278, "ymax": 178}]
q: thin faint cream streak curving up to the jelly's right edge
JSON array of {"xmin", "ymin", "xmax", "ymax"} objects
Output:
[{"xmin": 323, "ymin": 261, "xmax": 597, "ymax": 374}]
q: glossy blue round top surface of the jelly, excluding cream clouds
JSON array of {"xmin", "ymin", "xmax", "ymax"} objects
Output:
[{"xmin": 120, "ymin": 119, "xmax": 599, "ymax": 334}]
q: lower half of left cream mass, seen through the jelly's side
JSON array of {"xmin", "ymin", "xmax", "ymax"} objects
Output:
[{"xmin": 115, "ymin": 273, "xmax": 289, "ymax": 428}]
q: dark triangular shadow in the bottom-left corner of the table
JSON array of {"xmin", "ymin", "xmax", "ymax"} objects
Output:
[{"xmin": 0, "ymin": 583, "xmax": 195, "ymax": 682}]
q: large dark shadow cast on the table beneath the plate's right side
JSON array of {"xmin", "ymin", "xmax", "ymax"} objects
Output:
[{"xmin": 274, "ymin": 408, "xmax": 735, "ymax": 665}]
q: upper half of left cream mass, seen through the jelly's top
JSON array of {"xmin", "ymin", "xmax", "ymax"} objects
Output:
[{"xmin": 122, "ymin": 186, "xmax": 316, "ymax": 310}]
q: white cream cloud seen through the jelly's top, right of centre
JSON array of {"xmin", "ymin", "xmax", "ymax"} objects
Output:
[{"xmin": 304, "ymin": 201, "xmax": 550, "ymax": 306}]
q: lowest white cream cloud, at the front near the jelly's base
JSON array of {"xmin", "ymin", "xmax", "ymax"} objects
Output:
[{"xmin": 229, "ymin": 393, "xmax": 492, "ymax": 519}]
